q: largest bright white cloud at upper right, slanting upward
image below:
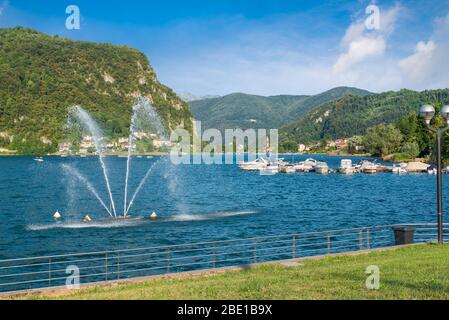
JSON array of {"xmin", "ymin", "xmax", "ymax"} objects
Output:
[{"xmin": 333, "ymin": 6, "xmax": 400, "ymax": 74}]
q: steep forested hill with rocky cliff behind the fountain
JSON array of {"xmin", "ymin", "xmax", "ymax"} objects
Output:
[{"xmin": 0, "ymin": 27, "xmax": 192, "ymax": 153}]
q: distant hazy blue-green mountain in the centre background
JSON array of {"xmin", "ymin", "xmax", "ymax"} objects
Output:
[{"xmin": 190, "ymin": 87, "xmax": 369, "ymax": 130}]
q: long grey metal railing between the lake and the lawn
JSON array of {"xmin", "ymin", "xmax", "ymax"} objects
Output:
[{"xmin": 0, "ymin": 224, "xmax": 449, "ymax": 292}]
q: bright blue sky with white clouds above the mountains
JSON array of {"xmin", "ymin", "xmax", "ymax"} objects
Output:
[{"xmin": 0, "ymin": 0, "xmax": 449, "ymax": 95}]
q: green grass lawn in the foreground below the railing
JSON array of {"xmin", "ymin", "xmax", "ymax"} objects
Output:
[{"xmin": 7, "ymin": 244, "xmax": 449, "ymax": 300}]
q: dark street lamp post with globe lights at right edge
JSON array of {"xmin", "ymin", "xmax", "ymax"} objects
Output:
[{"xmin": 419, "ymin": 105, "xmax": 449, "ymax": 244}]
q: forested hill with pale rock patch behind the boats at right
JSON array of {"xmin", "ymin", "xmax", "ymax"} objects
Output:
[{"xmin": 281, "ymin": 89, "xmax": 449, "ymax": 143}]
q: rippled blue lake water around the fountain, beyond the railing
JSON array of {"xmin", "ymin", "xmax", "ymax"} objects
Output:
[{"xmin": 0, "ymin": 156, "xmax": 449, "ymax": 259}]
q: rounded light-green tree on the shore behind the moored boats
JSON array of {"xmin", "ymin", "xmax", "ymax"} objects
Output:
[{"xmin": 363, "ymin": 124, "xmax": 403, "ymax": 156}]
